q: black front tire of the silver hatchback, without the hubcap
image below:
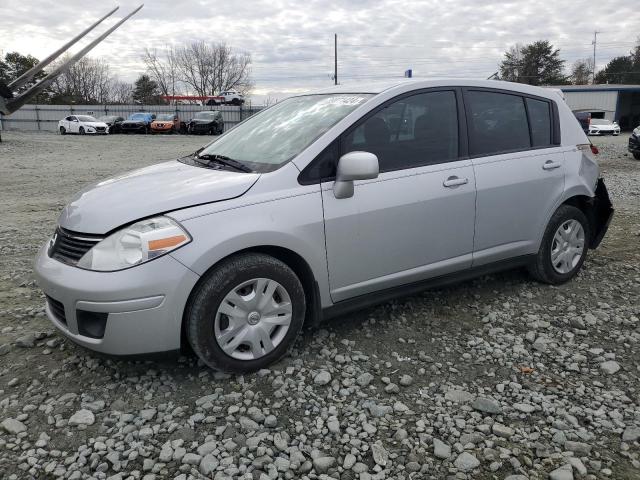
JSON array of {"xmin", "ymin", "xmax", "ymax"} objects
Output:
[{"xmin": 185, "ymin": 253, "xmax": 306, "ymax": 373}]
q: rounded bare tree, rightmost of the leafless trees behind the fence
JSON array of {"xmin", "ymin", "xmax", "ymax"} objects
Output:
[{"xmin": 175, "ymin": 41, "xmax": 252, "ymax": 96}]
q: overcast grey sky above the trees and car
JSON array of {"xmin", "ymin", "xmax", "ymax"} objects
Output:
[{"xmin": 0, "ymin": 0, "xmax": 640, "ymax": 101}]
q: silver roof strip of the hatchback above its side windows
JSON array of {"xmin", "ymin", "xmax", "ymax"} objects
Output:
[{"xmin": 300, "ymin": 78, "xmax": 561, "ymax": 100}]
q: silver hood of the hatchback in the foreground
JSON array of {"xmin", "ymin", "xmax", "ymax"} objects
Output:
[{"xmin": 59, "ymin": 160, "xmax": 260, "ymax": 234}]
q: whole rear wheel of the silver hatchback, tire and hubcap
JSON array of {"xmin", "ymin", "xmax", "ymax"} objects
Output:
[{"xmin": 529, "ymin": 205, "xmax": 591, "ymax": 285}]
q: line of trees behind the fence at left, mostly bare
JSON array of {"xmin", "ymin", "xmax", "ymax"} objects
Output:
[{"xmin": 0, "ymin": 41, "xmax": 253, "ymax": 105}]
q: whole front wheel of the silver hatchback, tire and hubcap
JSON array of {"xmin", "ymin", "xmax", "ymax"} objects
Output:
[{"xmin": 185, "ymin": 253, "xmax": 305, "ymax": 373}]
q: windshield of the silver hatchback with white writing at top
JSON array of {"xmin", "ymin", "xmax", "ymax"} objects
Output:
[{"xmin": 201, "ymin": 94, "xmax": 372, "ymax": 172}]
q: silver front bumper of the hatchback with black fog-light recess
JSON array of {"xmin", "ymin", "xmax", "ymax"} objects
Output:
[{"xmin": 35, "ymin": 244, "xmax": 199, "ymax": 355}]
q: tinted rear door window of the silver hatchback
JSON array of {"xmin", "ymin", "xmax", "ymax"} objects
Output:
[{"xmin": 465, "ymin": 90, "xmax": 531, "ymax": 156}]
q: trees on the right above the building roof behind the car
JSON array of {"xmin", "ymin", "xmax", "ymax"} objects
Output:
[{"xmin": 495, "ymin": 37, "xmax": 640, "ymax": 85}]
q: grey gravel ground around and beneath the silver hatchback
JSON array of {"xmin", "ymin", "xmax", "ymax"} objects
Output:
[{"xmin": 0, "ymin": 132, "xmax": 640, "ymax": 480}]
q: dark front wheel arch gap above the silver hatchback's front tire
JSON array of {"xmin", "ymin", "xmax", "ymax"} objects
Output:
[{"xmin": 180, "ymin": 245, "xmax": 322, "ymax": 350}]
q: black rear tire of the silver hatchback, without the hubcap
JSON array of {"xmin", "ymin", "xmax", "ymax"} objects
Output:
[{"xmin": 529, "ymin": 205, "xmax": 591, "ymax": 285}]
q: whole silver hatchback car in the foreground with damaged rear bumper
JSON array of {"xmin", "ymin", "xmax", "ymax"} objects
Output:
[{"xmin": 35, "ymin": 80, "xmax": 613, "ymax": 372}]
